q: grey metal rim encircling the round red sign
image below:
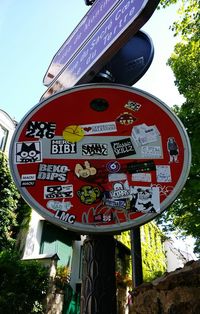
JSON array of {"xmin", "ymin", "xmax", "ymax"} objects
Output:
[{"xmin": 9, "ymin": 83, "xmax": 191, "ymax": 234}]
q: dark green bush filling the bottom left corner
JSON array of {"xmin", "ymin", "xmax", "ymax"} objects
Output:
[{"xmin": 0, "ymin": 250, "xmax": 48, "ymax": 314}]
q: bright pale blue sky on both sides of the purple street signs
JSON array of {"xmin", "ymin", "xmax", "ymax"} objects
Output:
[{"xmin": 0, "ymin": 0, "xmax": 183, "ymax": 121}]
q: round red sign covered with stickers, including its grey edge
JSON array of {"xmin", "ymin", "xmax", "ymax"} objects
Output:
[{"xmin": 10, "ymin": 84, "xmax": 190, "ymax": 233}]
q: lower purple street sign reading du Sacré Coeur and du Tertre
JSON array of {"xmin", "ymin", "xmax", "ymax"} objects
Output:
[{"xmin": 41, "ymin": 0, "xmax": 159, "ymax": 100}]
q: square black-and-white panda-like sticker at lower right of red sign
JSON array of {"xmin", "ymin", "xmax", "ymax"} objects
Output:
[{"xmin": 131, "ymin": 186, "xmax": 160, "ymax": 213}]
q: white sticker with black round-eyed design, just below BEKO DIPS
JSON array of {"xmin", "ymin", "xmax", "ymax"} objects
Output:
[{"xmin": 44, "ymin": 184, "xmax": 73, "ymax": 199}]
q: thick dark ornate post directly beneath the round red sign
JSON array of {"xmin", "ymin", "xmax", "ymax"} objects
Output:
[{"xmin": 81, "ymin": 235, "xmax": 117, "ymax": 314}]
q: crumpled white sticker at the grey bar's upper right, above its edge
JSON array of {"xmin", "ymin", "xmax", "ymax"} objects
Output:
[{"xmin": 131, "ymin": 123, "xmax": 160, "ymax": 146}]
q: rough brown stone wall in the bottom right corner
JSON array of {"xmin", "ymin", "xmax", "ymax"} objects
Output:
[{"xmin": 131, "ymin": 261, "xmax": 200, "ymax": 314}]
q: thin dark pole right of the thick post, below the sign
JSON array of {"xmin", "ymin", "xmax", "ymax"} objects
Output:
[{"xmin": 131, "ymin": 227, "xmax": 143, "ymax": 288}]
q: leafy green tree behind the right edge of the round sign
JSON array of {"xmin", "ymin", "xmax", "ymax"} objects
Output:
[{"xmin": 157, "ymin": 0, "xmax": 200, "ymax": 253}]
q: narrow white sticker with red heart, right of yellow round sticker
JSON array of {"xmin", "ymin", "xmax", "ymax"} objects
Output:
[{"xmin": 81, "ymin": 122, "xmax": 117, "ymax": 135}]
